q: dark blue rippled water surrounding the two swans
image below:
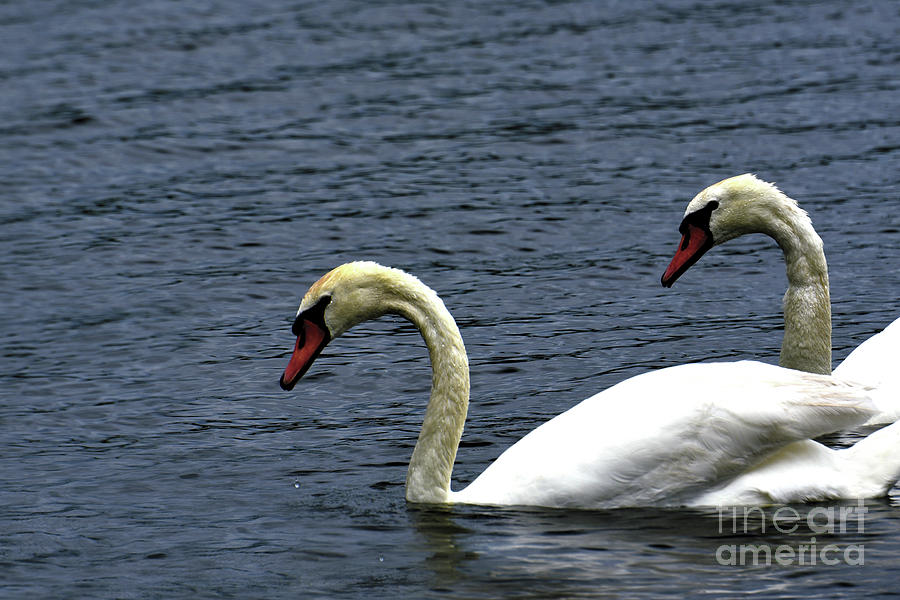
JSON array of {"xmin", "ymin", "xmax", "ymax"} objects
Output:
[{"xmin": 0, "ymin": 0, "xmax": 900, "ymax": 598}]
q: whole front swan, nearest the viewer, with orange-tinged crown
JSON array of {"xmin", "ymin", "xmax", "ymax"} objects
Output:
[{"xmin": 280, "ymin": 262, "xmax": 900, "ymax": 508}]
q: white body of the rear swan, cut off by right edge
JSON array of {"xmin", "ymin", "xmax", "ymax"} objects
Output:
[{"xmin": 834, "ymin": 319, "xmax": 900, "ymax": 425}]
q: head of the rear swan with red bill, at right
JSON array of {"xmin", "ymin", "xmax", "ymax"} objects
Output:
[{"xmin": 662, "ymin": 173, "xmax": 805, "ymax": 287}]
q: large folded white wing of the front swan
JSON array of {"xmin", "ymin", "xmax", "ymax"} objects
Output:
[{"xmin": 451, "ymin": 361, "xmax": 872, "ymax": 508}]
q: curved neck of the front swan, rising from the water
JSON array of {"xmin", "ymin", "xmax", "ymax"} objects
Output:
[{"xmin": 389, "ymin": 276, "xmax": 469, "ymax": 503}]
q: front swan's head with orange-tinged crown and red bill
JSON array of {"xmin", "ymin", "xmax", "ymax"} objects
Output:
[{"xmin": 280, "ymin": 261, "xmax": 412, "ymax": 390}]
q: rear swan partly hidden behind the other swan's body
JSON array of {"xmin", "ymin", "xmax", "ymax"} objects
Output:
[{"xmin": 662, "ymin": 173, "xmax": 900, "ymax": 425}]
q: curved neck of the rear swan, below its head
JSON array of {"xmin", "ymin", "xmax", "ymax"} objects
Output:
[{"xmin": 769, "ymin": 197, "xmax": 831, "ymax": 375}]
